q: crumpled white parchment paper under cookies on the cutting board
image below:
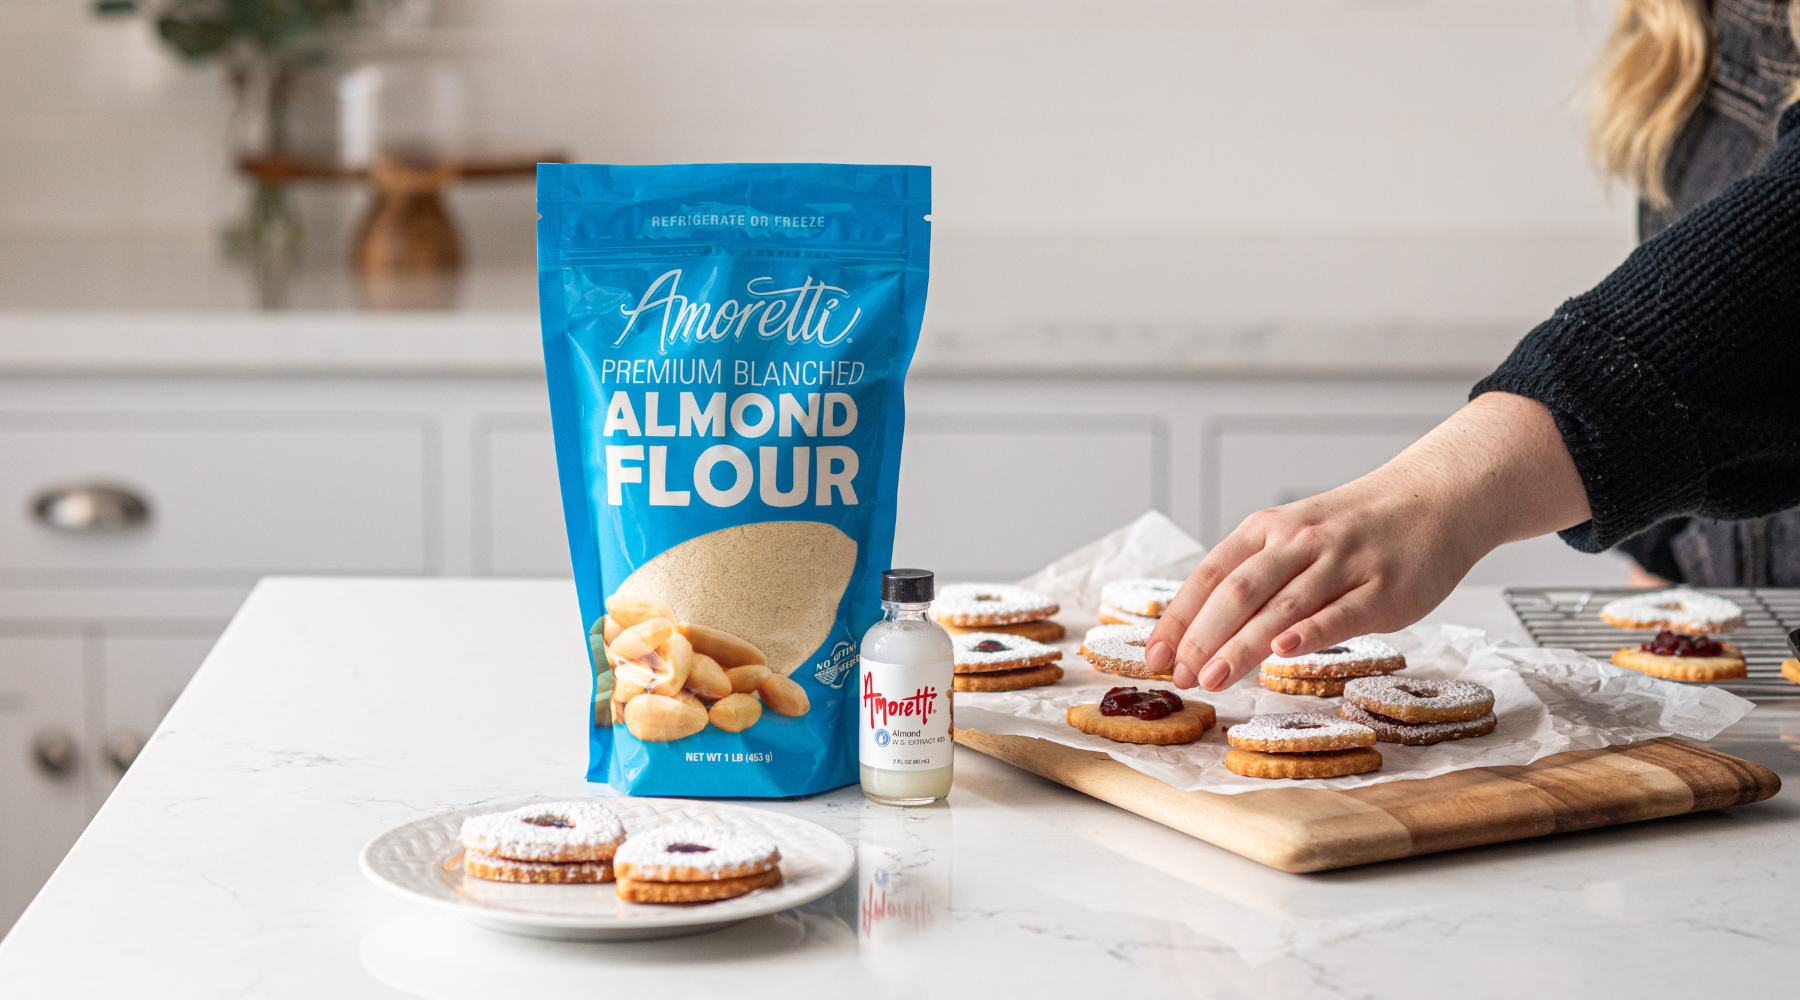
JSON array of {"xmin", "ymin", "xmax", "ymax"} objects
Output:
[{"xmin": 956, "ymin": 513, "xmax": 1753, "ymax": 793}]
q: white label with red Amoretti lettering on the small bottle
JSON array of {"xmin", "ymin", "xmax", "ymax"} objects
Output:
[{"xmin": 859, "ymin": 656, "xmax": 956, "ymax": 772}]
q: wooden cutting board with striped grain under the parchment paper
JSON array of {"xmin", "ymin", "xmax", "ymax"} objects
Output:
[{"xmin": 956, "ymin": 728, "xmax": 1782, "ymax": 872}]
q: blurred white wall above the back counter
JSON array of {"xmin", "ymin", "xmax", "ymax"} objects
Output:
[{"xmin": 0, "ymin": 0, "xmax": 1631, "ymax": 335}]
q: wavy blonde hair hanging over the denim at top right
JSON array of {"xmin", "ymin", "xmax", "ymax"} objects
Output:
[{"xmin": 1588, "ymin": 0, "xmax": 1800, "ymax": 207}]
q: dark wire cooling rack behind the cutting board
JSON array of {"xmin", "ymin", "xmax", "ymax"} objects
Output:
[{"xmin": 1507, "ymin": 586, "xmax": 1800, "ymax": 698}]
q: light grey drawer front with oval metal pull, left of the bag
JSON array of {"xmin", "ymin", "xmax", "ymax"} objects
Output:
[{"xmin": 0, "ymin": 415, "xmax": 434, "ymax": 574}]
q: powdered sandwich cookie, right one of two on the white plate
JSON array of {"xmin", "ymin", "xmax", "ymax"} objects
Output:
[{"xmin": 612, "ymin": 824, "xmax": 781, "ymax": 903}]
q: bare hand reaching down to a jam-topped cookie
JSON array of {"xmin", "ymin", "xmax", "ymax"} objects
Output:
[{"xmin": 1145, "ymin": 392, "xmax": 1589, "ymax": 691}]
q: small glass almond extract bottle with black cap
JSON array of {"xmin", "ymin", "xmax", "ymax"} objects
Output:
[{"xmin": 859, "ymin": 570, "xmax": 956, "ymax": 806}]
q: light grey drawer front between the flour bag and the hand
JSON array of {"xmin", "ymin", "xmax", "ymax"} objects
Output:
[{"xmin": 895, "ymin": 415, "xmax": 1170, "ymax": 581}]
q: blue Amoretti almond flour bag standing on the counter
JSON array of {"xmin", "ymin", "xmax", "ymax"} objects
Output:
[{"xmin": 538, "ymin": 164, "xmax": 931, "ymax": 797}]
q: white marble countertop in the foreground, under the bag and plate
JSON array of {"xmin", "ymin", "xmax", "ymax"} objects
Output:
[{"xmin": 0, "ymin": 579, "xmax": 1800, "ymax": 1000}]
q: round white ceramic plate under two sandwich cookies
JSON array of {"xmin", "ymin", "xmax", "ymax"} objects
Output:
[{"xmin": 362, "ymin": 799, "xmax": 857, "ymax": 941}]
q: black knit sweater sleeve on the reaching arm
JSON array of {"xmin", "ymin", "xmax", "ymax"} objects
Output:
[{"xmin": 1469, "ymin": 104, "xmax": 1800, "ymax": 552}]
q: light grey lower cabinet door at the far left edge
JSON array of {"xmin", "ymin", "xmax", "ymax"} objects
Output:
[{"xmin": 0, "ymin": 629, "xmax": 99, "ymax": 928}]
